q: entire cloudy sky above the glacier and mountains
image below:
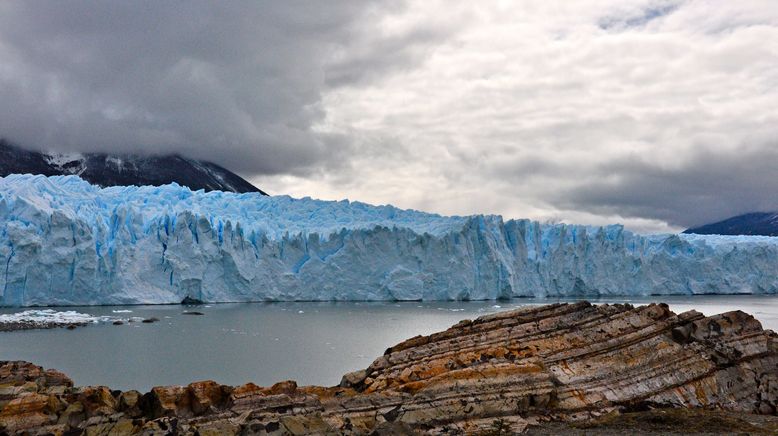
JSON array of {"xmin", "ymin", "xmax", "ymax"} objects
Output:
[{"xmin": 0, "ymin": 0, "xmax": 778, "ymax": 232}]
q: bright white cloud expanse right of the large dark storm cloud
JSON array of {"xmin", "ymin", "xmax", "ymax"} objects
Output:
[{"xmin": 257, "ymin": 1, "xmax": 778, "ymax": 231}]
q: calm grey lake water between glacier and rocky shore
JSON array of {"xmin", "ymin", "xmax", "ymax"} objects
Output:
[{"xmin": 0, "ymin": 296, "xmax": 778, "ymax": 391}]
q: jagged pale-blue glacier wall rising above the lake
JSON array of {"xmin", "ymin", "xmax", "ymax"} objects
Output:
[{"xmin": 0, "ymin": 174, "xmax": 778, "ymax": 306}]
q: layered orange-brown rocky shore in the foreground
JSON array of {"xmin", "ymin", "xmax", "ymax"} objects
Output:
[{"xmin": 0, "ymin": 302, "xmax": 778, "ymax": 435}]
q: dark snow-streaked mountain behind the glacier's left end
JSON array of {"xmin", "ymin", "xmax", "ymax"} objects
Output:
[{"xmin": 0, "ymin": 139, "xmax": 267, "ymax": 195}]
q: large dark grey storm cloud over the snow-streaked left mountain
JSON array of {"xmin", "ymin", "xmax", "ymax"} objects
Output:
[{"xmin": 0, "ymin": 0, "xmax": 436, "ymax": 174}]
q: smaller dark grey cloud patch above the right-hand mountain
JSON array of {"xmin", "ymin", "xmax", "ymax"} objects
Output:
[{"xmin": 556, "ymin": 146, "xmax": 778, "ymax": 227}]
